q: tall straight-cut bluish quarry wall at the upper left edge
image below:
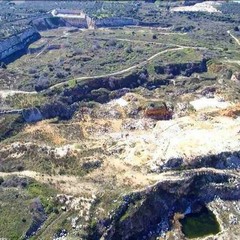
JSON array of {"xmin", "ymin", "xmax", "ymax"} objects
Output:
[{"xmin": 0, "ymin": 27, "xmax": 41, "ymax": 63}]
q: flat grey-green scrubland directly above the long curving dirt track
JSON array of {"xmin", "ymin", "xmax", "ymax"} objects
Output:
[{"xmin": 5, "ymin": 30, "xmax": 167, "ymax": 89}]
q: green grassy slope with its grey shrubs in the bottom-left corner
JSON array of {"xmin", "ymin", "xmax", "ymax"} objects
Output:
[{"xmin": 0, "ymin": 176, "xmax": 56, "ymax": 240}]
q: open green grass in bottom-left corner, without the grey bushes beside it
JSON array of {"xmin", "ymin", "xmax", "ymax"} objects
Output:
[{"xmin": 0, "ymin": 177, "xmax": 56, "ymax": 240}]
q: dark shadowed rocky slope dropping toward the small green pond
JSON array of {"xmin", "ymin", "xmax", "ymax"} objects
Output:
[{"xmin": 97, "ymin": 170, "xmax": 240, "ymax": 240}]
